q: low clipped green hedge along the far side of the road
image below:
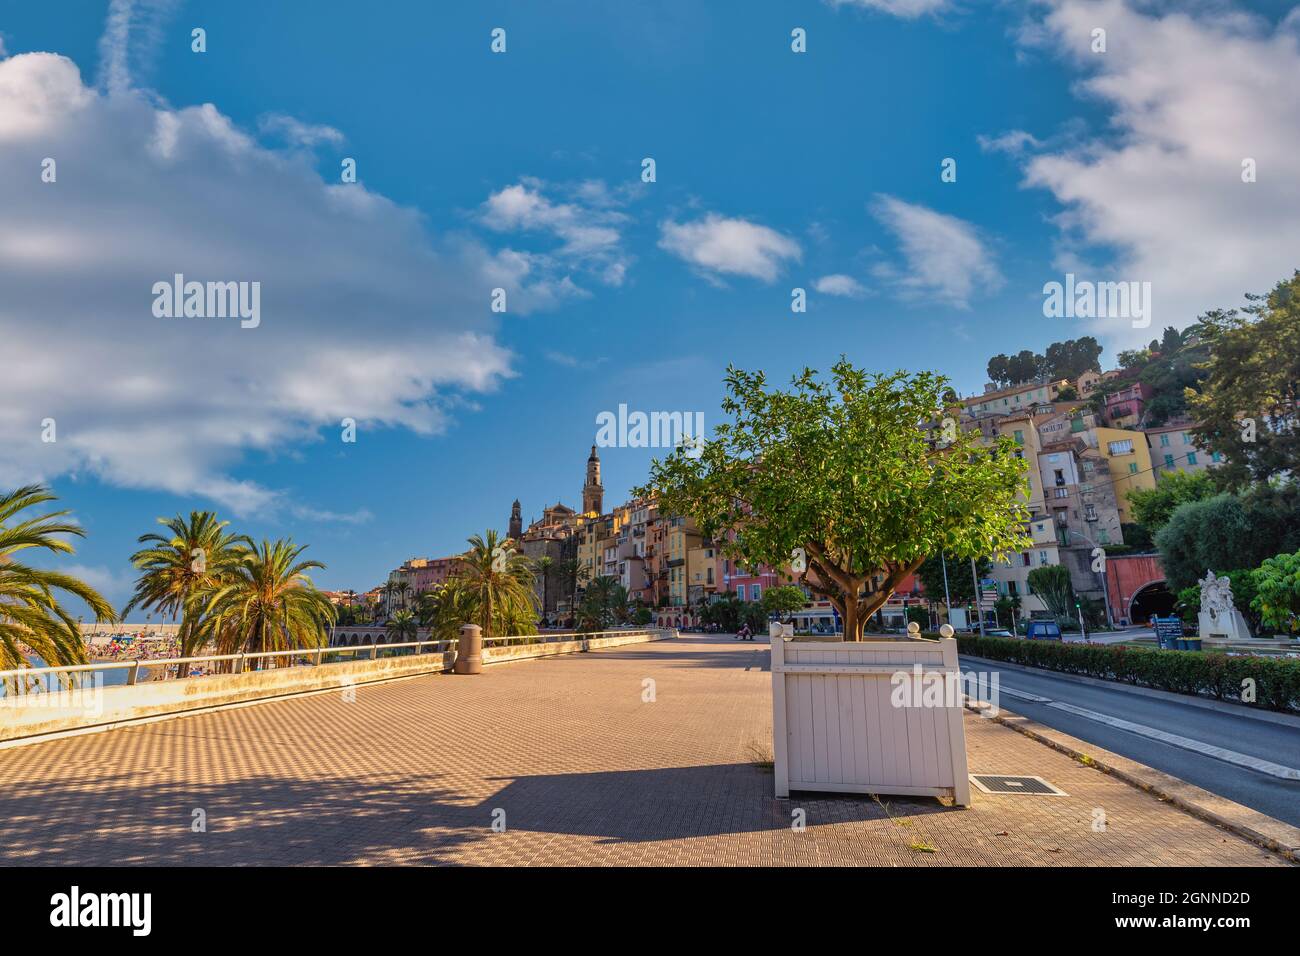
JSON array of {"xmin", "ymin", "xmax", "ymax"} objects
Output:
[{"xmin": 957, "ymin": 635, "xmax": 1300, "ymax": 713}]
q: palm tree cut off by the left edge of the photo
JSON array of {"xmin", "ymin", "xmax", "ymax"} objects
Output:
[{"xmin": 0, "ymin": 485, "xmax": 117, "ymax": 670}]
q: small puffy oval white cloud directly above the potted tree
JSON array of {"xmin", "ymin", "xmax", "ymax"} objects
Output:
[{"xmin": 659, "ymin": 212, "xmax": 803, "ymax": 282}]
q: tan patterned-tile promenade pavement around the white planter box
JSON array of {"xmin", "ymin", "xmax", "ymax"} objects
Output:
[{"xmin": 0, "ymin": 637, "xmax": 1286, "ymax": 866}]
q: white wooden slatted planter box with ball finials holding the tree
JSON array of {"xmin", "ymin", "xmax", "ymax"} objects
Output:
[{"xmin": 772, "ymin": 626, "xmax": 971, "ymax": 806}]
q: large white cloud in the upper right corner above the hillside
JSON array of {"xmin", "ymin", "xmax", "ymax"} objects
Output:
[{"xmin": 1022, "ymin": 0, "xmax": 1300, "ymax": 346}]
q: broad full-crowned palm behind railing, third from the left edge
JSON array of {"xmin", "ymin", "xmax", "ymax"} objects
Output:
[{"xmin": 199, "ymin": 540, "xmax": 334, "ymax": 654}]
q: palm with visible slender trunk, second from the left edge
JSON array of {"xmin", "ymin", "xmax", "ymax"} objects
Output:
[{"xmin": 122, "ymin": 511, "xmax": 252, "ymax": 657}]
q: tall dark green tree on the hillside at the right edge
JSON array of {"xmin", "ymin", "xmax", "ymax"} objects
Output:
[{"xmin": 1187, "ymin": 272, "xmax": 1300, "ymax": 486}]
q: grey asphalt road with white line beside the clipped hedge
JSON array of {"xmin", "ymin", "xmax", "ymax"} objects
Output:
[{"xmin": 962, "ymin": 659, "xmax": 1300, "ymax": 826}]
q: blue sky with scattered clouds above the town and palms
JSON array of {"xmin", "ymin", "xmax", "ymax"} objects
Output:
[{"xmin": 0, "ymin": 0, "xmax": 1300, "ymax": 616}]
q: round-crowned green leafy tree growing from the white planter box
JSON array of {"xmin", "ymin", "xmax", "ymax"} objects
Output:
[{"xmin": 634, "ymin": 359, "xmax": 1028, "ymax": 641}]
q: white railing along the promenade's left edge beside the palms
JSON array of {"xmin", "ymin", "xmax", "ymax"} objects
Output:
[{"xmin": 0, "ymin": 627, "xmax": 666, "ymax": 693}]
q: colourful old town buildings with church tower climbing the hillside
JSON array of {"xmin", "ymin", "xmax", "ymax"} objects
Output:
[{"xmin": 358, "ymin": 348, "xmax": 1219, "ymax": 630}]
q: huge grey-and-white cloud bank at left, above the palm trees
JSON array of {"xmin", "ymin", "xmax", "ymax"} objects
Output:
[{"xmin": 0, "ymin": 53, "xmax": 511, "ymax": 518}]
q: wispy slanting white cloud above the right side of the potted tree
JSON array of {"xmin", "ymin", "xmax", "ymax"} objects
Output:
[{"xmin": 871, "ymin": 195, "xmax": 1002, "ymax": 308}]
